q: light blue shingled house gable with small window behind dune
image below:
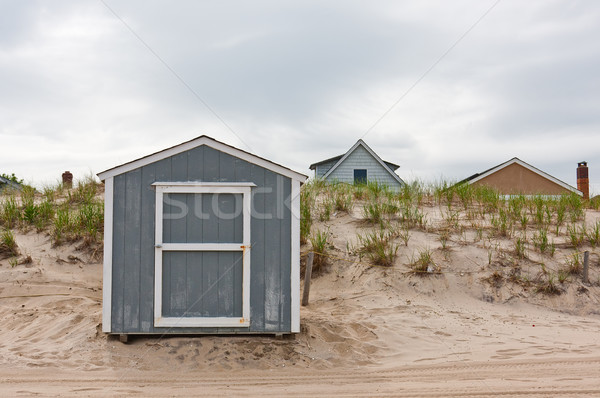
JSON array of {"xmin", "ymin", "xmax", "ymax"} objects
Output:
[{"xmin": 310, "ymin": 140, "xmax": 404, "ymax": 189}]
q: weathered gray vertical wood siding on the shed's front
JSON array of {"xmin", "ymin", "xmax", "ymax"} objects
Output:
[{"xmin": 111, "ymin": 146, "xmax": 291, "ymax": 333}]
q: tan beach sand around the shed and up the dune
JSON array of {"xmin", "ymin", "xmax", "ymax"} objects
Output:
[{"xmin": 0, "ymin": 207, "xmax": 600, "ymax": 397}]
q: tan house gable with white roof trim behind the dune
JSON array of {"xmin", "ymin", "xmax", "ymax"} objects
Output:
[{"xmin": 461, "ymin": 158, "xmax": 583, "ymax": 195}]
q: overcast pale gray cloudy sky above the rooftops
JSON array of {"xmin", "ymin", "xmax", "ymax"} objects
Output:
[{"xmin": 0, "ymin": 0, "xmax": 600, "ymax": 193}]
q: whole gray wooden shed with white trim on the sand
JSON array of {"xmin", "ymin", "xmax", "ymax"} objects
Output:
[{"xmin": 98, "ymin": 136, "xmax": 307, "ymax": 335}]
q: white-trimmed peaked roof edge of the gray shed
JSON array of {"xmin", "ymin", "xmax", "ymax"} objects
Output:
[{"xmin": 98, "ymin": 135, "xmax": 308, "ymax": 182}]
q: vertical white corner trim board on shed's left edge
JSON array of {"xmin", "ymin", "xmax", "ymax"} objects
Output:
[{"xmin": 102, "ymin": 177, "xmax": 114, "ymax": 333}]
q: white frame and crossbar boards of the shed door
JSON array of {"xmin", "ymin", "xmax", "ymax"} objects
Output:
[{"xmin": 152, "ymin": 182, "xmax": 256, "ymax": 327}]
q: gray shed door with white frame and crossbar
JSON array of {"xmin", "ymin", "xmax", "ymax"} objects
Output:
[{"xmin": 153, "ymin": 182, "xmax": 254, "ymax": 327}]
